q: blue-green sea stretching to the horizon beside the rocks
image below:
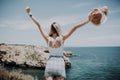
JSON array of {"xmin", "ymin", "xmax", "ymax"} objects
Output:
[{"xmin": 2, "ymin": 47, "xmax": 120, "ymax": 80}]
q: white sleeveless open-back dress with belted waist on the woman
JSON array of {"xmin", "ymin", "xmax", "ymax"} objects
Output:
[{"xmin": 45, "ymin": 36, "xmax": 66, "ymax": 78}]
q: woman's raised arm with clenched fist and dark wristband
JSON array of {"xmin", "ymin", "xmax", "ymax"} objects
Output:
[{"xmin": 26, "ymin": 7, "xmax": 48, "ymax": 42}]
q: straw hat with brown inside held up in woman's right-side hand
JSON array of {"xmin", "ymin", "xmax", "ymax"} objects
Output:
[{"xmin": 89, "ymin": 6, "xmax": 108, "ymax": 25}]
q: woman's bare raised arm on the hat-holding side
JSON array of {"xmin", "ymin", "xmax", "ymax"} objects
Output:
[{"xmin": 63, "ymin": 19, "xmax": 90, "ymax": 40}]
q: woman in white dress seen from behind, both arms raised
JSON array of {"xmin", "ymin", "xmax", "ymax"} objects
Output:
[{"xmin": 26, "ymin": 7, "xmax": 107, "ymax": 80}]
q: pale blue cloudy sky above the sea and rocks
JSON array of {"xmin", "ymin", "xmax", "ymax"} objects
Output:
[{"xmin": 0, "ymin": 0, "xmax": 120, "ymax": 47}]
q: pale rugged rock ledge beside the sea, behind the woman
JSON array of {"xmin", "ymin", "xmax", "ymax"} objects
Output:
[{"xmin": 0, "ymin": 43, "xmax": 71, "ymax": 68}]
